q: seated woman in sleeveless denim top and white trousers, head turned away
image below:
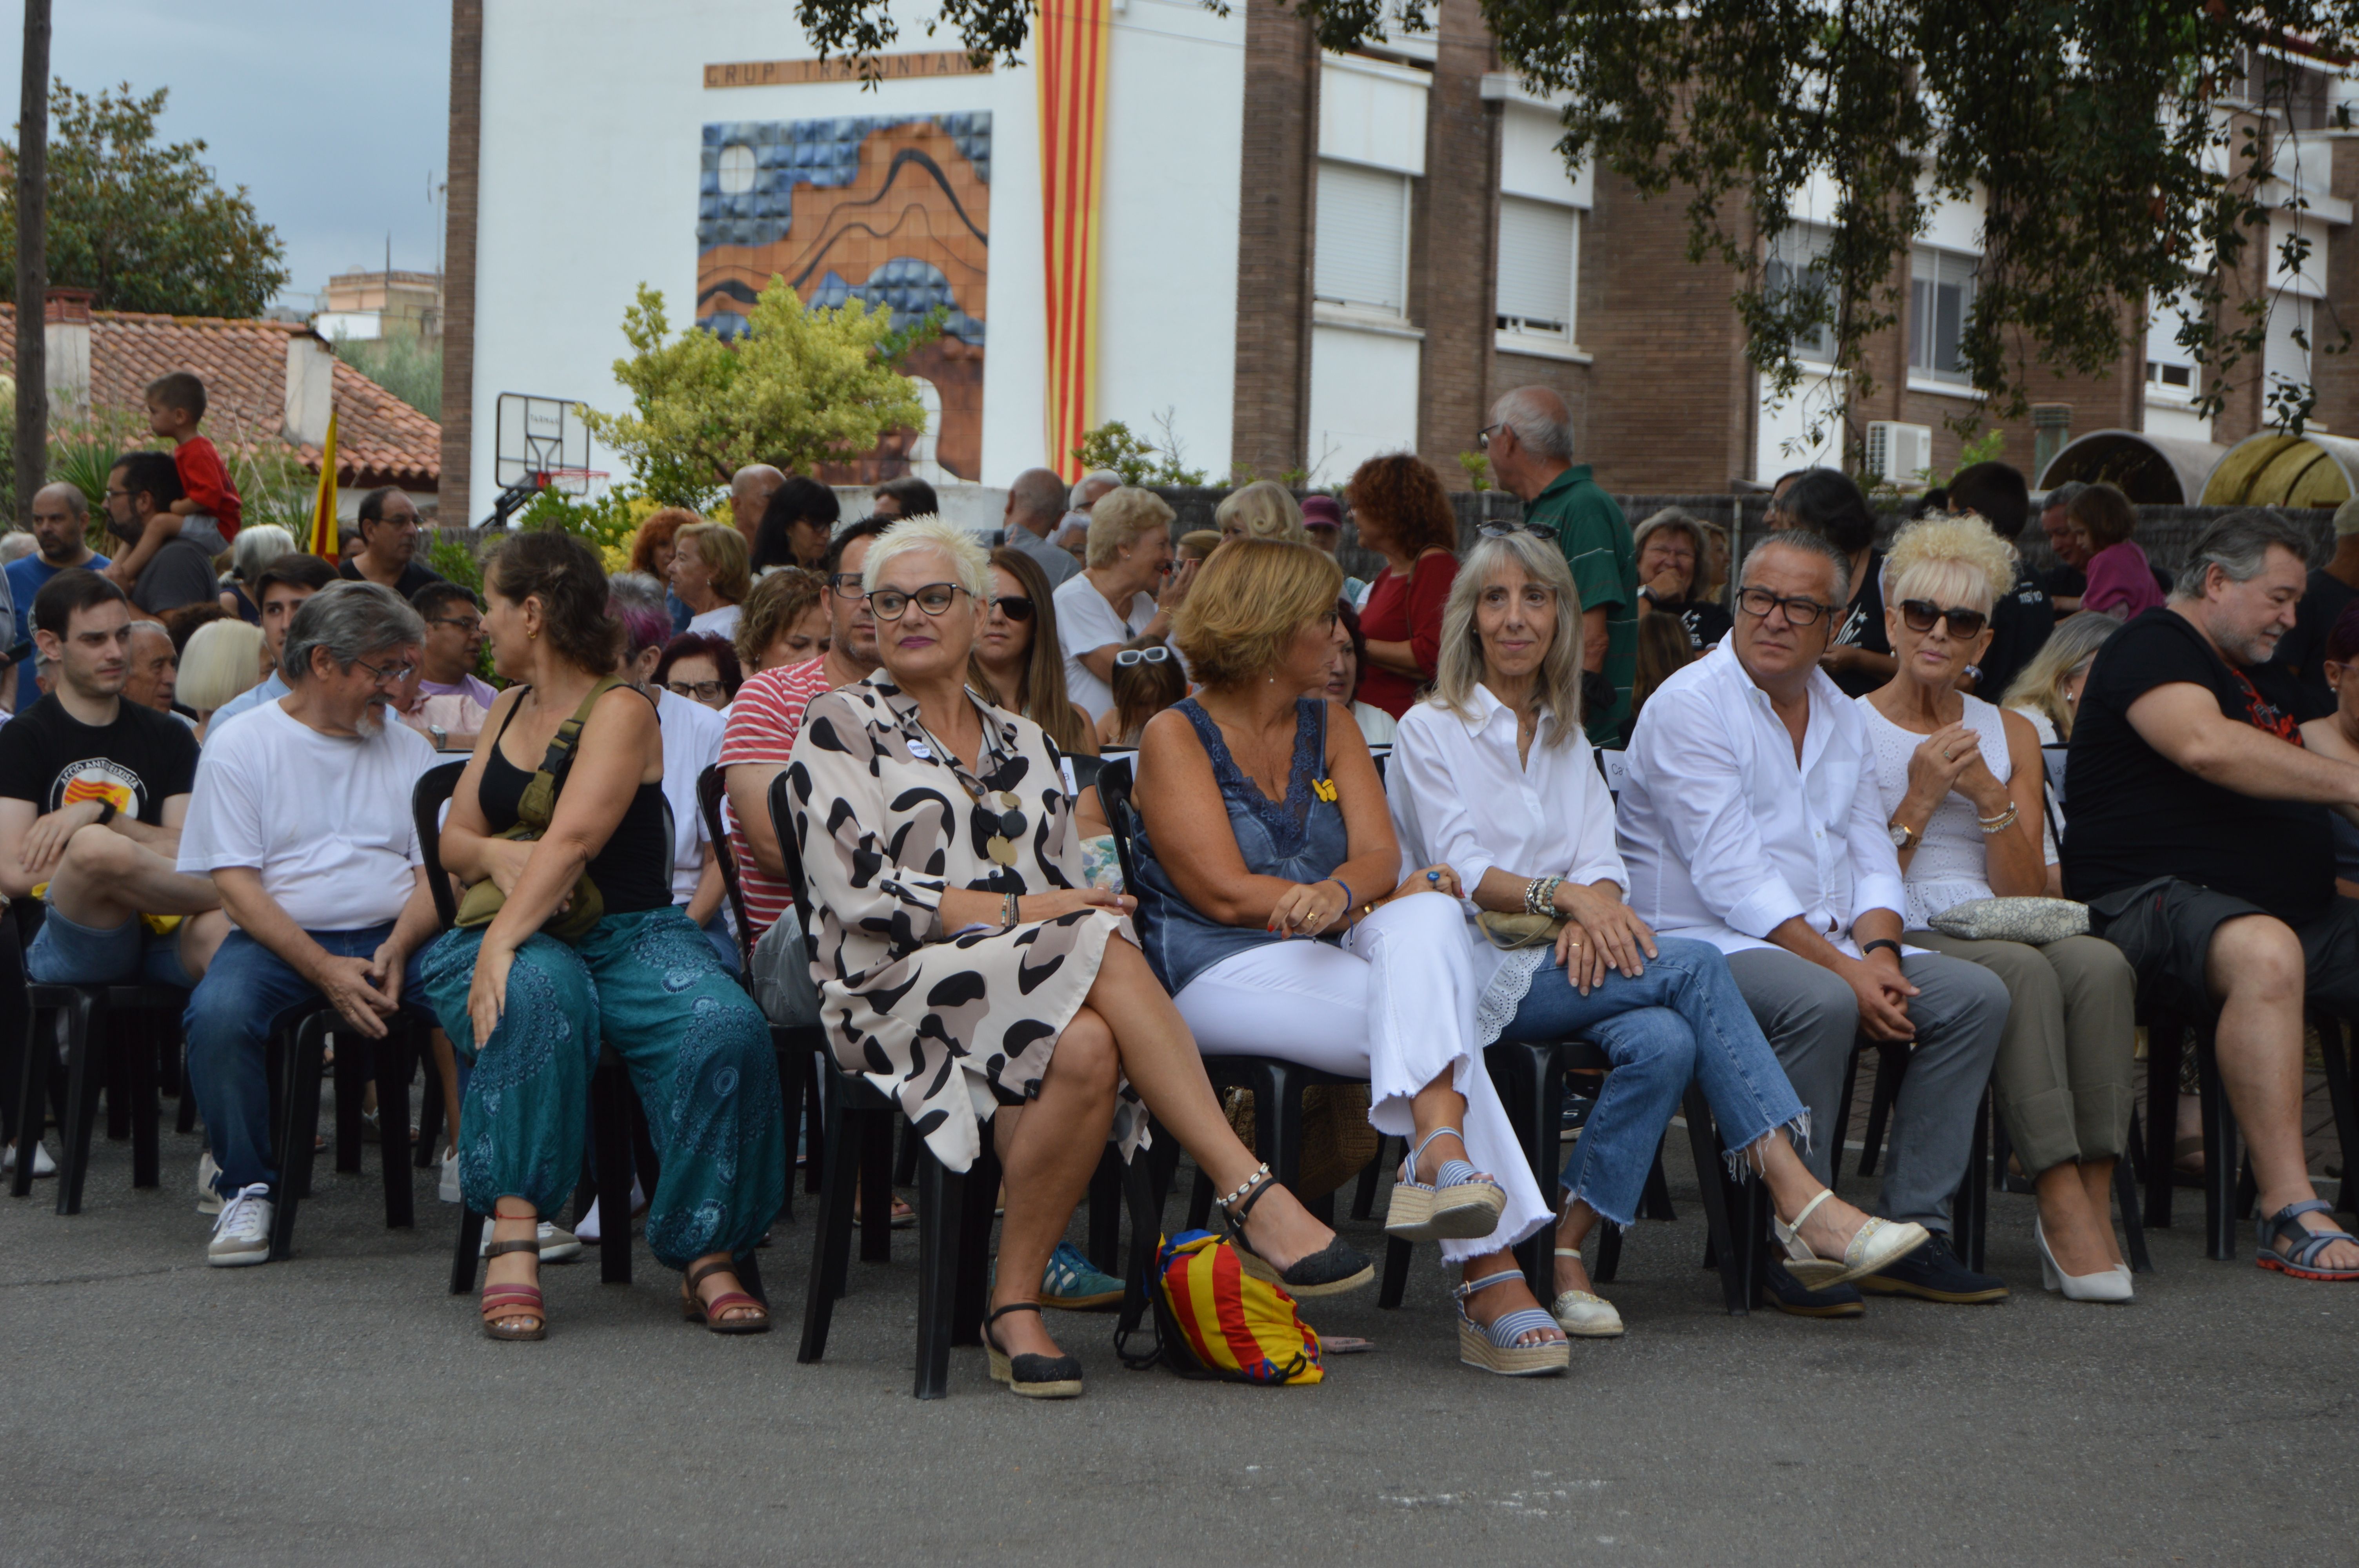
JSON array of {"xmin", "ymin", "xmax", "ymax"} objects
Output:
[{"xmin": 1135, "ymin": 540, "xmax": 1569, "ymax": 1375}]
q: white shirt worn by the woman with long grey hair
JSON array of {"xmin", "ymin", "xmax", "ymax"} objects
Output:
[{"xmin": 1385, "ymin": 686, "xmax": 1628, "ymax": 985}]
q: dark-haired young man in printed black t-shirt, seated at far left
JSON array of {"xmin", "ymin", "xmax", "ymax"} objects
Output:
[{"xmin": 0, "ymin": 568, "xmax": 229, "ymax": 985}]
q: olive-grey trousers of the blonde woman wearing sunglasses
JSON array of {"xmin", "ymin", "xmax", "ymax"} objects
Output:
[{"xmin": 1908, "ymin": 931, "xmax": 2137, "ymax": 1177}]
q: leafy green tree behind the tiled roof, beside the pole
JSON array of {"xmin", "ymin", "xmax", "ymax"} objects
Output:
[{"xmin": 0, "ymin": 83, "xmax": 288, "ymax": 316}]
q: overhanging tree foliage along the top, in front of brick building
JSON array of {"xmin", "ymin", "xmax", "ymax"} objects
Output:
[{"xmin": 797, "ymin": 0, "xmax": 2359, "ymax": 441}]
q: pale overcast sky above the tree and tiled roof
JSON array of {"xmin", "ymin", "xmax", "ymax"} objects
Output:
[{"xmin": 0, "ymin": 0, "xmax": 451, "ymax": 304}]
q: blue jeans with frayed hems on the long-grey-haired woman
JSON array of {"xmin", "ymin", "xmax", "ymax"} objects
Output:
[{"xmin": 1503, "ymin": 936, "xmax": 1809, "ymax": 1226}]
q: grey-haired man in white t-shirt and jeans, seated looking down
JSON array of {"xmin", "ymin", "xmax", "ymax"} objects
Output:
[{"xmin": 179, "ymin": 583, "xmax": 434, "ymax": 1269}]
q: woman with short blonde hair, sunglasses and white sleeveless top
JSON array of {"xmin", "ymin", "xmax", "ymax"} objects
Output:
[{"xmin": 1859, "ymin": 519, "xmax": 2135, "ymax": 1301}]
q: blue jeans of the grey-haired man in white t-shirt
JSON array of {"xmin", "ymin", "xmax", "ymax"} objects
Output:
[{"xmin": 182, "ymin": 913, "xmax": 425, "ymax": 1196}]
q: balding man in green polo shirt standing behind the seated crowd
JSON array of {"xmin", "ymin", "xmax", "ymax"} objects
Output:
[{"xmin": 1481, "ymin": 387, "xmax": 1637, "ymax": 748}]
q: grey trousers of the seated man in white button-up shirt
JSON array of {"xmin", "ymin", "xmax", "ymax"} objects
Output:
[{"xmin": 1729, "ymin": 948, "xmax": 2008, "ymax": 1236}]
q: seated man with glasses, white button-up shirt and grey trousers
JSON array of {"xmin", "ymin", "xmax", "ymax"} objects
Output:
[{"xmin": 1616, "ymin": 533, "xmax": 2008, "ymax": 1318}]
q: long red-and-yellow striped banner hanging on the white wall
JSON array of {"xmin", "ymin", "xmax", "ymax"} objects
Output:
[{"xmin": 1033, "ymin": 0, "xmax": 1109, "ymax": 481}]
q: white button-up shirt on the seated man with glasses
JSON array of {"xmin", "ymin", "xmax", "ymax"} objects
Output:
[{"xmin": 1621, "ymin": 641, "xmax": 1906, "ymax": 957}]
